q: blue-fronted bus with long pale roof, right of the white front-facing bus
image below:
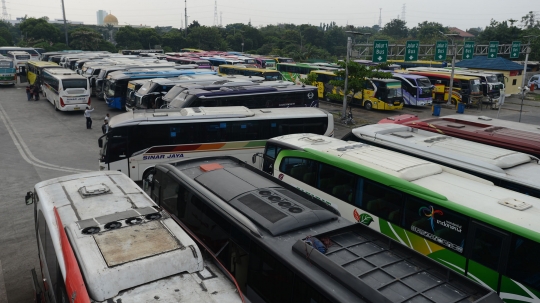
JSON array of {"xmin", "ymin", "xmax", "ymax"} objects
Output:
[{"xmin": 103, "ymin": 69, "xmax": 216, "ymax": 110}]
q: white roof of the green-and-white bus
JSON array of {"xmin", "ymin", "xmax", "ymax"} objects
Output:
[{"xmin": 268, "ymin": 134, "xmax": 540, "ymax": 242}]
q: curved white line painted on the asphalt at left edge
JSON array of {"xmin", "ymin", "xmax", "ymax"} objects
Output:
[{"xmin": 0, "ymin": 105, "xmax": 89, "ymax": 173}]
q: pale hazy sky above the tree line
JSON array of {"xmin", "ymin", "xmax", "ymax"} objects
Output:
[{"xmin": 4, "ymin": 0, "xmax": 540, "ymax": 30}]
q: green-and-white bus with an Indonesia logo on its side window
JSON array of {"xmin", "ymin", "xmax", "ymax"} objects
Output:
[{"xmin": 255, "ymin": 134, "xmax": 540, "ymax": 302}]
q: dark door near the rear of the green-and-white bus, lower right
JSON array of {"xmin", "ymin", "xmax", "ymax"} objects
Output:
[{"xmin": 463, "ymin": 221, "xmax": 510, "ymax": 293}]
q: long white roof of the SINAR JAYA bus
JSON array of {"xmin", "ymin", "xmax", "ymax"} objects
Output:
[{"xmin": 109, "ymin": 106, "xmax": 328, "ymax": 128}]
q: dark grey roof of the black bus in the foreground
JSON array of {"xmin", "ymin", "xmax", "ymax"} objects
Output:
[{"xmin": 158, "ymin": 157, "xmax": 500, "ymax": 303}]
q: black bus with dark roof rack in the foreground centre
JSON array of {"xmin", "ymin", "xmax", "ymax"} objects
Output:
[{"xmin": 151, "ymin": 157, "xmax": 502, "ymax": 303}]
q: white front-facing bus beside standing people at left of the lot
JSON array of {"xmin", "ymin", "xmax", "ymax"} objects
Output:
[{"xmin": 42, "ymin": 68, "xmax": 91, "ymax": 111}]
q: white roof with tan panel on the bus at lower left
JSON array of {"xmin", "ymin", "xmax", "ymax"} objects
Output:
[{"xmin": 35, "ymin": 171, "xmax": 238, "ymax": 302}]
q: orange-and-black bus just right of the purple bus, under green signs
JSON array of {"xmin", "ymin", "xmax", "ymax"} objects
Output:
[{"xmin": 402, "ymin": 71, "xmax": 482, "ymax": 104}]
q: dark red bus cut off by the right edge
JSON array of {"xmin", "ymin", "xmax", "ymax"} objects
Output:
[{"xmin": 379, "ymin": 115, "xmax": 540, "ymax": 157}]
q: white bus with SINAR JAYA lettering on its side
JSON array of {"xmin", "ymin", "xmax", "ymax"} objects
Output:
[{"xmin": 98, "ymin": 106, "xmax": 334, "ymax": 181}]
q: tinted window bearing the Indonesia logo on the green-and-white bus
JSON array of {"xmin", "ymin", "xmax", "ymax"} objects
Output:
[{"xmin": 404, "ymin": 197, "xmax": 467, "ymax": 253}]
